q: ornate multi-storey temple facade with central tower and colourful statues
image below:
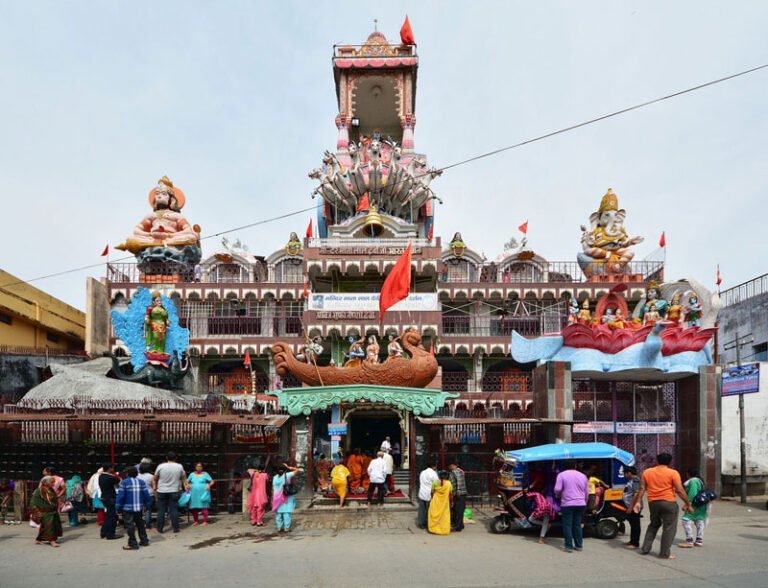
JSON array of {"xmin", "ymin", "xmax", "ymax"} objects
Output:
[{"xmin": 0, "ymin": 32, "xmax": 719, "ymax": 506}]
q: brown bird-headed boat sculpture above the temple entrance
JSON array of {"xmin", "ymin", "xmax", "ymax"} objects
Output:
[{"xmin": 272, "ymin": 330, "xmax": 437, "ymax": 388}]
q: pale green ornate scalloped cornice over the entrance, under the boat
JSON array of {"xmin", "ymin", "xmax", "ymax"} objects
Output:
[{"xmin": 269, "ymin": 385, "xmax": 459, "ymax": 416}]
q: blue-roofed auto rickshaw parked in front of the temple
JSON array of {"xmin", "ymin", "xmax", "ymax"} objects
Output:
[{"xmin": 491, "ymin": 443, "xmax": 635, "ymax": 539}]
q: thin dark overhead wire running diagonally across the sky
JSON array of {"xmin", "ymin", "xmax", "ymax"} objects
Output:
[{"xmin": 0, "ymin": 63, "xmax": 768, "ymax": 288}]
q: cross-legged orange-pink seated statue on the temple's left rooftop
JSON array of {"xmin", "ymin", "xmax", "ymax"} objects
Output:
[{"xmin": 115, "ymin": 176, "xmax": 202, "ymax": 273}]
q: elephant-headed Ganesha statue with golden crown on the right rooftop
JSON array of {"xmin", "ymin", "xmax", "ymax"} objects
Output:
[{"xmin": 576, "ymin": 188, "xmax": 643, "ymax": 278}]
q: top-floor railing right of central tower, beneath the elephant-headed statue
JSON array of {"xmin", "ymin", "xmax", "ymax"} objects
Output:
[{"xmin": 440, "ymin": 261, "xmax": 664, "ymax": 284}]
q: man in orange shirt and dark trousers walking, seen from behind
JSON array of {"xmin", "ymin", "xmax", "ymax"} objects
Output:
[{"xmin": 632, "ymin": 453, "xmax": 693, "ymax": 559}]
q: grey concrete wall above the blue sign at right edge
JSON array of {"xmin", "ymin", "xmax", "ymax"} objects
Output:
[{"xmin": 718, "ymin": 294, "xmax": 768, "ymax": 363}]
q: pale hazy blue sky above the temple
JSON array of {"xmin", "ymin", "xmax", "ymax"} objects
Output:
[{"xmin": 0, "ymin": 0, "xmax": 768, "ymax": 309}]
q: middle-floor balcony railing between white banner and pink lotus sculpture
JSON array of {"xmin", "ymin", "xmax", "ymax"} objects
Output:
[{"xmin": 442, "ymin": 314, "xmax": 568, "ymax": 337}]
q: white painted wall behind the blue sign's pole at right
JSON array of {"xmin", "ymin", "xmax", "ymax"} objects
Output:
[{"xmin": 721, "ymin": 361, "xmax": 768, "ymax": 476}]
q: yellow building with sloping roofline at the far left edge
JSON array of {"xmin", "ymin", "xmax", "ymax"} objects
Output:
[{"xmin": 0, "ymin": 270, "xmax": 85, "ymax": 352}]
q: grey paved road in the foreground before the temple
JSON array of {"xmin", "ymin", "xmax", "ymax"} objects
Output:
[{"xmin": 0, "ymin": 502, "xmax": 768, "ymax": 588}]
